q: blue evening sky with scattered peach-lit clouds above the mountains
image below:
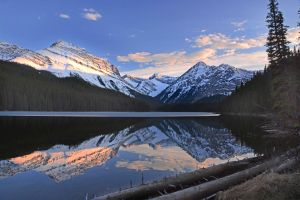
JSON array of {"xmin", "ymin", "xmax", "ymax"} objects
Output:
[{"xmin": 0, "ymin": 0, "xmax": 300, "ymax": 77}]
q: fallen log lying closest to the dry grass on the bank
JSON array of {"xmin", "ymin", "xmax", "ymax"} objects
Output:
[{"xmin": 152, "ymin": 155, "xmax": 295, "ymax": 200}]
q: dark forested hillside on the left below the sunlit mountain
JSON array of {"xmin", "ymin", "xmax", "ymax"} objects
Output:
[{"xmin": 0, "ymin": 61, "xmax": 149, "ymax": 111}]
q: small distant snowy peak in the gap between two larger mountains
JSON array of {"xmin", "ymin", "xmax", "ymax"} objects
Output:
[{"xmin": 123, "ymin": 73, "xmax": 177, "ymax": 97}]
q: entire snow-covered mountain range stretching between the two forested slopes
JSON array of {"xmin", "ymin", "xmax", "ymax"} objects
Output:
[{"xmin": 0, "ymin": 41, "xmax": 253, "ymax": 103}]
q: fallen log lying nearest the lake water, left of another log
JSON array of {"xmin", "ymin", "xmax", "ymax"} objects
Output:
[{"xmin": 94, "ymin": 157, "xmax": 263, "ymax": 200}]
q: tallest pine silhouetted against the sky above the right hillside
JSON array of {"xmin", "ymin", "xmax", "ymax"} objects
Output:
[{"xmin": 266, "ymin": 0, "xmax": 290, "ymax": 66}]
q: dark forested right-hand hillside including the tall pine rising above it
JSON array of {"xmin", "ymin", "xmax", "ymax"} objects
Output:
[{"xmin": 221, "ymin": 0, "xmax": 300, "ymax": 127}]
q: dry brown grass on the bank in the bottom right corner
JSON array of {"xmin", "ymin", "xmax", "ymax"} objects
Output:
[{"xmin": 216, "ymin": 173, "xmax": 300, "ymax": 200}]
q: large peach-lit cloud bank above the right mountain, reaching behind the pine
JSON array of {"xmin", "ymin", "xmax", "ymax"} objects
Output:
[{"xmin": 117, "ymin": 28, "xmax": 299, "ymax": 77}]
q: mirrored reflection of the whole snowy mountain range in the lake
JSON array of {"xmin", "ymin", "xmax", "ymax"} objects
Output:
[{"xmin": 0, "ymin": 119, "xmax": 252, "ymax": 182}]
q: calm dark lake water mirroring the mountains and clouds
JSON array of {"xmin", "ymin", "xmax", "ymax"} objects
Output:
[{"xmin": 0, "ymin": 117, "xmax": 298, "ymax": 200}]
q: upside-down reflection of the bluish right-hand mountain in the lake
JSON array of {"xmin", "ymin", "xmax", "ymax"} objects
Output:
[{"xmin": 158, "ymin": 120, "xmax": 251, "ymax": 162}]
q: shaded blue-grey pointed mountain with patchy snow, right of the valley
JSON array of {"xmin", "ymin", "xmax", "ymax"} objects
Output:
[{"xmin": 157, "ymin": 62, "xmax": 254, "ymax": 103}]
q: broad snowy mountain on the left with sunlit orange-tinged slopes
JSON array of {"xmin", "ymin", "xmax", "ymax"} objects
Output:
[{"xmin": 0, "ymin": 41, "xmax": 138, "ymax": 96}]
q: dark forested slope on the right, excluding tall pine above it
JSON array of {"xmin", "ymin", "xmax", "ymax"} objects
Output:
[{"xmin": 222, "ymin": 49, "xmax": 300, "ymax": 127}]
